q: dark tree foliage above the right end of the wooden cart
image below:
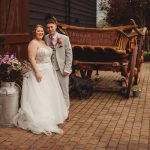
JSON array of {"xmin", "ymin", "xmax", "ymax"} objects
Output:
[{"xmin": 99, "ymin": 0, "xmax": 150, "ymax": 27}]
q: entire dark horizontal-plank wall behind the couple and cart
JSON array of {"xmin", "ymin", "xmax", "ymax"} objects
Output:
[{"xmin": 29, "ymin": 0, "xmax": 96, "ymax": 31}]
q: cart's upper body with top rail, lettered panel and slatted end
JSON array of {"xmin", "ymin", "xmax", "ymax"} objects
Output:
[{"xmin": 58, "ymin": 24, "xmax": 138, "ymax": 50}]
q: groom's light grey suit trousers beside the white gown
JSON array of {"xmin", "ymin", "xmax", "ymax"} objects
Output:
[{"xmin": 56, "ymin": 70, "xmax": 70, "ymax": 109}]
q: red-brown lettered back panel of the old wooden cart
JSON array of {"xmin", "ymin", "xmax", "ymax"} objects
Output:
[{"xmin": 67, "ymin": 29, "xmax": 118, "ymax": 46}]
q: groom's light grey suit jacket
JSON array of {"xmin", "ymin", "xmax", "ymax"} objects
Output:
[{"xmin": 44, "ymin": 33, "xmax": 73, "ymax": 74}]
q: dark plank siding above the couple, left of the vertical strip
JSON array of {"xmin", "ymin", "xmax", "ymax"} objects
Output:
[{"xmin": 29, "ymin": 0, "xmax": 66, "ymax": 31}]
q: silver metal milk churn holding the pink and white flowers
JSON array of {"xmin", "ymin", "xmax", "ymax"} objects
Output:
[{"xmin": 0, "ymin": 82, "xmax": 19, "ymax": 127}]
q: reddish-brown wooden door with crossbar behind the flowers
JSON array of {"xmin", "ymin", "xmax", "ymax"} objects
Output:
[{"xmin": 0, "ymin": 0, "xmax": 30, "ymax": 58}]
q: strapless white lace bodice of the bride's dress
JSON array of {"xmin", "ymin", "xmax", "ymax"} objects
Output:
[{"xmin": 36, "ymin": 47, "xmax": 52, "ymax": 63}]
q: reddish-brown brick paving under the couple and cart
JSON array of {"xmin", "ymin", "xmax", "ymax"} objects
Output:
[{"xmin": 0, "ymin": 63, "xmax": 150, "ymax": 150}]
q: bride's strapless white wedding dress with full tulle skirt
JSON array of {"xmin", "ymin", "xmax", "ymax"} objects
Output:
[{"xmin": 13, "ymin": 47, "xmax": 68, "ymax": 135}]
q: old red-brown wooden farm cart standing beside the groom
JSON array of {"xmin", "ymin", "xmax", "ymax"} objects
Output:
[{"xmin": 58, "ymin": 20, "xmax": 147, "ymax": 98}]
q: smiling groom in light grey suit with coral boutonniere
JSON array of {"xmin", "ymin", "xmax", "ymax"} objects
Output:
[{"xmin": 45, "ymin": 17, "xmax": 72, "ymax": 109}]
